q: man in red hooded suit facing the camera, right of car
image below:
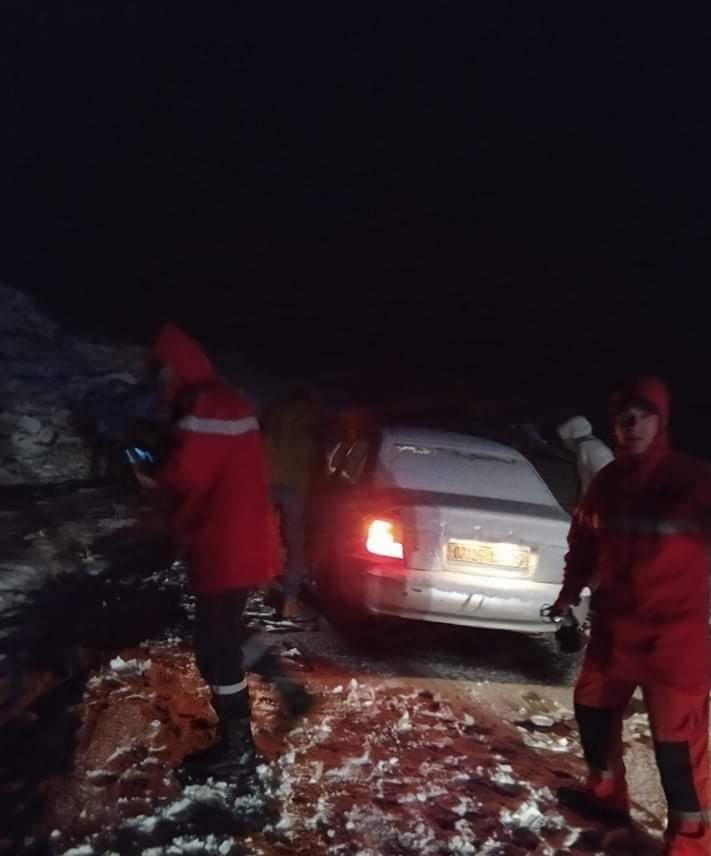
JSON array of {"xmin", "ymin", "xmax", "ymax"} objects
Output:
[{"xmin": 554, "ymin": 378, "xmax": 711, "ymax": 856}]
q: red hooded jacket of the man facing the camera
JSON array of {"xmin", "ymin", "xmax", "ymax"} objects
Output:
[{"xmin": 563, "ymin": 378, "xmax": 711, "ymax": 687}]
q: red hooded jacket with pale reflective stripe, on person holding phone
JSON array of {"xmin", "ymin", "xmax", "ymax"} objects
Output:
[{"xmin": 152, "ymin": 324, "xmax": 280, "ymax": 593}]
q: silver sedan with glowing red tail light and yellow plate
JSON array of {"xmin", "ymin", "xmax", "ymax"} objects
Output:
[{"xmin": 307, "ymin": 427, "xmax": 587, "ymax": 633}]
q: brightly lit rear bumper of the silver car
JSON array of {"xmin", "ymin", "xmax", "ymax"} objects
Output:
[{"xmin": 363, "ymin": 568, "xmax": 587, "ymax": 633}]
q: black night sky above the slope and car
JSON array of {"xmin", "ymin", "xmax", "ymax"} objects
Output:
[{"xmin": 0, "ymin": 0, "xmax": 711, "ymax": 445}]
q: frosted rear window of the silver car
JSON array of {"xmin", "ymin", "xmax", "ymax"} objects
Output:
[{"xmin": 376, "ymin": 443, "xmax": 557, "ymax": 505}]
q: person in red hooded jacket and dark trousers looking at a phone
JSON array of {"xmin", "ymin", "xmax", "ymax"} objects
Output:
[{"xmin": 137, "ymin": 324, "xmax": 280, "ymax": 781}]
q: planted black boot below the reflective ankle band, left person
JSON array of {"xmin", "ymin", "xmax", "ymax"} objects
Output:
[{"xmin": 177, "ymin": 712, "xmax": 257, "ymax": 785}]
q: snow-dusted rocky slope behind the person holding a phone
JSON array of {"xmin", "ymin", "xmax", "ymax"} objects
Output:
[{"xmin": 0, "ymin": 284, "xmax": 300, "ymax": 485}]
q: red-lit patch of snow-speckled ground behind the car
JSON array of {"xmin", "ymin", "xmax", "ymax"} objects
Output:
[{"xmin": 47, "ymin": 644, "xmax": 600, "ymax": 854}]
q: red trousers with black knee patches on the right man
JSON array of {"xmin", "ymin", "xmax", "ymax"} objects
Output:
[{"xmin": 575, "ymin": 658, "xmax": 711, "ymax": 856}]
